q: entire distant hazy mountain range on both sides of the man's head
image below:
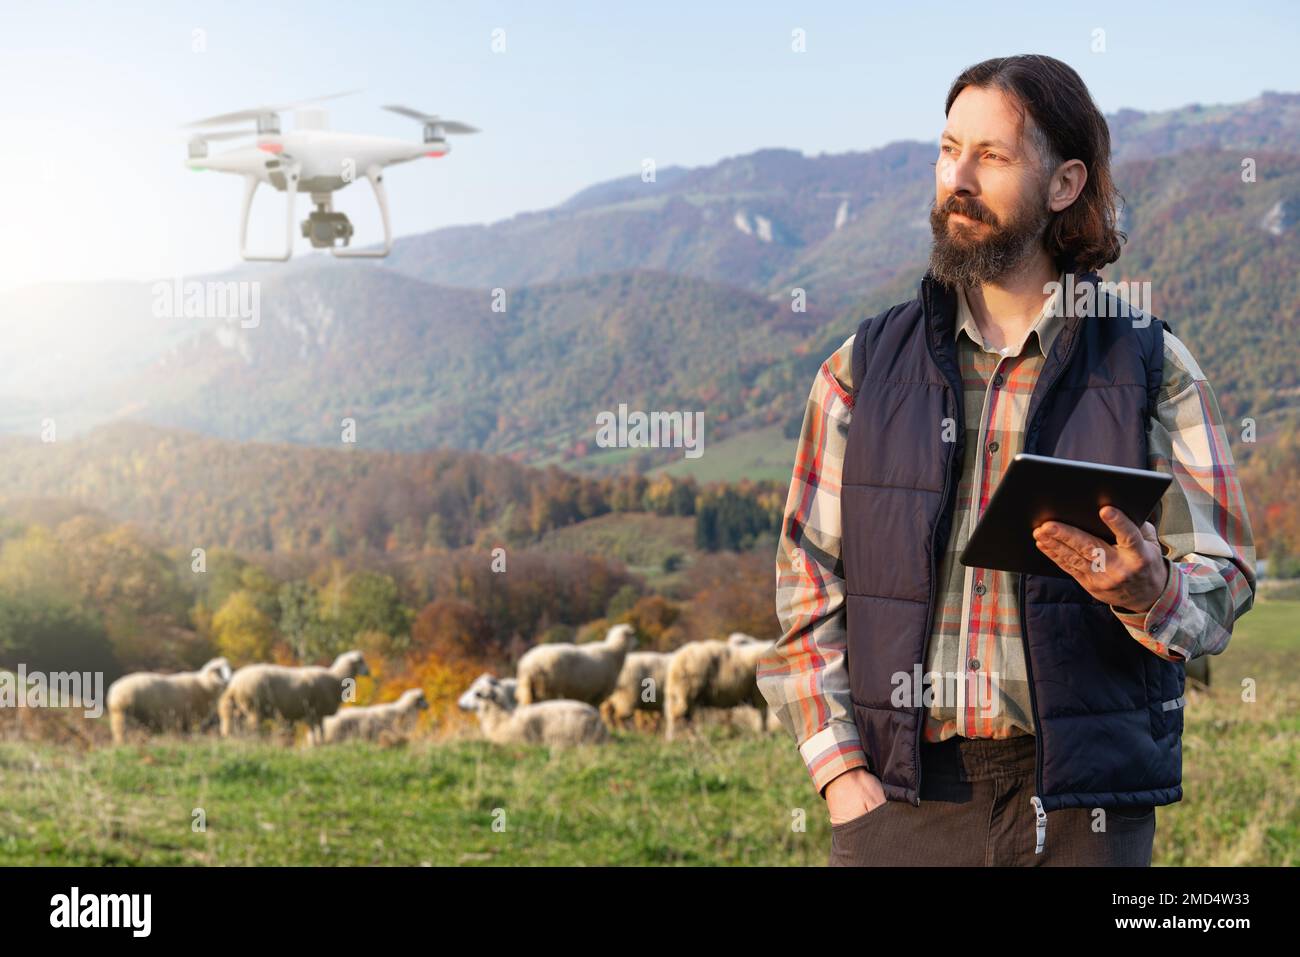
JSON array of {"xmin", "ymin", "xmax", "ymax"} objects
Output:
[{"xmin": 0, "ymin": 92, "xmax": 1300, "ymax": 468}]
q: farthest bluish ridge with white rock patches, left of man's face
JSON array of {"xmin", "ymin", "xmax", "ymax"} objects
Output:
[{"xmin": 385, "ymin": 143, "xmax": 935, "ymax": 308}]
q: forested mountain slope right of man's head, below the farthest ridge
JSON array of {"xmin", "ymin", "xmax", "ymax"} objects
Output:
[{"xmin": 1106, "ymin": 150, "xmax": 1300, "ymax": 426}]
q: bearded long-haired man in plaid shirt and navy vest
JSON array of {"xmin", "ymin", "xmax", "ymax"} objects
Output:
[{"xmin": 758, "ymin": 56, "xmax": 1255, "ymax": 865}]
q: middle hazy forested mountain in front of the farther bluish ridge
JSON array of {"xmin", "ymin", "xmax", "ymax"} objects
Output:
[{"xmin": 69, "ymin": 263, "xmax": 828, "ymax": 460}]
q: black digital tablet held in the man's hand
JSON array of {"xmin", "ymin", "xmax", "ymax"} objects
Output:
[{"xmin": 959, "ymin": 452, "xmax": 1174, "ymax": 579}]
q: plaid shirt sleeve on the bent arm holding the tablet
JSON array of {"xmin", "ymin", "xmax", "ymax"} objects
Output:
[{"xmin": 1112, "ymin": 329, "xmax": 1255, "ymax": 661}]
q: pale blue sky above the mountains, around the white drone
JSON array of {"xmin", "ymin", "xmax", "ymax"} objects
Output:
[{"xmin": 0, "ymin": 0, "xmax": 1300, "ymax": 290}]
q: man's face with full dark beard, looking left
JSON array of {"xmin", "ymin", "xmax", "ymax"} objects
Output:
[{"xmin": 930, "ymin": 87, "xmax": 1050, "ymax": 286}]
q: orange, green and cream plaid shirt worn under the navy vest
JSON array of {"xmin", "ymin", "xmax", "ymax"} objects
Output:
[{"xmin": 758, "ymin": 280, "xmax": 1255, "ymax": 793}]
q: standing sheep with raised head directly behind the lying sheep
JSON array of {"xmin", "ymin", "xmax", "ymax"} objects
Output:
[{"xmin": 515, "ymin": 624, "xmax": 637, "ymax": 706}]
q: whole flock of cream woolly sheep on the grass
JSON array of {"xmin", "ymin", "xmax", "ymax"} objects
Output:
[{"xmin": 108, "ymin": 624, "xmax": 771, "ymax": 746}]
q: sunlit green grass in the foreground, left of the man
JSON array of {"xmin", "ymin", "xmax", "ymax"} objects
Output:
[{"xmin": 0, "ymin": 728, "xmax": 829, "ymax": 865}]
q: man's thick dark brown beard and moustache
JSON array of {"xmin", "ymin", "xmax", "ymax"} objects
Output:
[{"xmin": 930, "ymin": 192, "xmax": 1050, "ymax": 287}]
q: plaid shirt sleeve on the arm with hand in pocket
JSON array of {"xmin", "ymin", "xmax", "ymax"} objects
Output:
[{"xmin": 758, "ymin": 335, "xmax": 868, "ymax": 797}]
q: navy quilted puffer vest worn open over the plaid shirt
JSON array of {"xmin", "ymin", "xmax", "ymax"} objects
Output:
[{"xmin": 841, "ymin": 273, "xmax": 1184, "ymax": 841}]
